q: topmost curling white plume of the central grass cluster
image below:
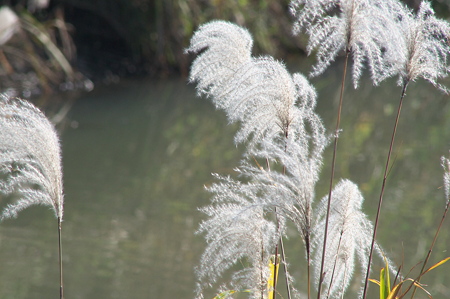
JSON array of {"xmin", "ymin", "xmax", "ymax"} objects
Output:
[{"xmin": 186, "ymin": 21, "xmax": 315, "ymax": 147}]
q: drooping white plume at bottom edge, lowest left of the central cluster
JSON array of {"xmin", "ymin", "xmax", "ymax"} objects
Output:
[{"xmin": 197, "ymin": 175, "xmax": 279, "ymax": 298}]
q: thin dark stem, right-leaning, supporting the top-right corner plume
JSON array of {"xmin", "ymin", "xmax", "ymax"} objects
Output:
[{"xmin": 363, "ymin": 81, "xmax": 409, "ymax": 299}]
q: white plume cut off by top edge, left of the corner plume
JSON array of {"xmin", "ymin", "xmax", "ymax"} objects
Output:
[{"xmin": 290, "ymin": 0, "xmax": 402, "ymax": 88}]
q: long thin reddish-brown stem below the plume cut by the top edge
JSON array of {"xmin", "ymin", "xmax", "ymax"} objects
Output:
[{"xmin": 317, "ymin": 50, "xmax": 350, "ymax": 299}]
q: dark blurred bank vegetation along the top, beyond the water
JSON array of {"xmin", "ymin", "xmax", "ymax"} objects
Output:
[{"xmin": 0, "ymin": 0, "xmax": 450, "ymax": 97}]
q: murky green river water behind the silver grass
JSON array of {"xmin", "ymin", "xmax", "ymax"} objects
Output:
[{"xmin": 0, "ymin": 69, "xmax": 450, "ymax": 299}]
